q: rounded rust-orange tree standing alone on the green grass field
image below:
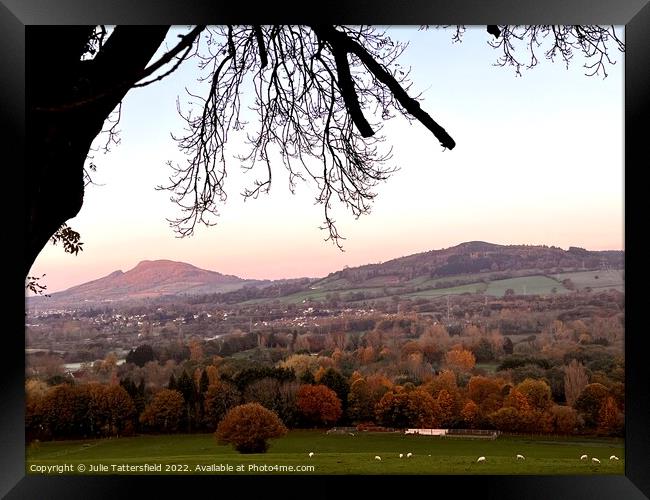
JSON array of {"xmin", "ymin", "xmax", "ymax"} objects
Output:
[{"xmin": 215, "ymin": 403, "xmax": 287, "ymax": 453}]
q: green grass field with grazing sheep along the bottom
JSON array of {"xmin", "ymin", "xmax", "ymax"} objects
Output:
[{"xmin": 26, "ymin": 430, "xmax": 624, "ymax": 475}]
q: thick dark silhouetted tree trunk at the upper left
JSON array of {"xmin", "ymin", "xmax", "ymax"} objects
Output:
[{"xmin": 24, "ymin": 26, "xmax": 169, "ymax": 276}]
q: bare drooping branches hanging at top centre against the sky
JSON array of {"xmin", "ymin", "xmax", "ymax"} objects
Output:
[{"xmin": 161, "ymin": 26, "xmax": 455, "ymax": 246}]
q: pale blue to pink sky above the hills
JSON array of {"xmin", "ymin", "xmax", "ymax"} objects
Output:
[{"xmin": 30, "ymin": 27, "xmax": 624, "ymax": 293}]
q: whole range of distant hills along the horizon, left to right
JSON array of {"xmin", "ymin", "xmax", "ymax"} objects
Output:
[{"xmin": 29, "ymin": 241, "xmax": 625, "ymax": 308}]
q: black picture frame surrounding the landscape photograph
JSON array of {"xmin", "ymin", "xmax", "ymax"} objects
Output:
[{"xmin": 0, "ymin": 0, "xmax": 650, "ymax": 500}]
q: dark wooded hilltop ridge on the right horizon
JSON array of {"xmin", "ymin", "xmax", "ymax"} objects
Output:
[{"xmin": 317, "ymin": 241, "xmax": 625, "ymax": 288}]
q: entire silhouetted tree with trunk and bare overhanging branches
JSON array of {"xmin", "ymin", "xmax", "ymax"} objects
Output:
[{"xmin": 24, "ymin": 25, "xmax": 624, "ymax": 280}]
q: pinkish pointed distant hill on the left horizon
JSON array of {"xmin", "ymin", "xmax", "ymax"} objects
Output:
[{"xmin": 35, "ymin": 260, "xmax": 262, "ymax": 303}]
